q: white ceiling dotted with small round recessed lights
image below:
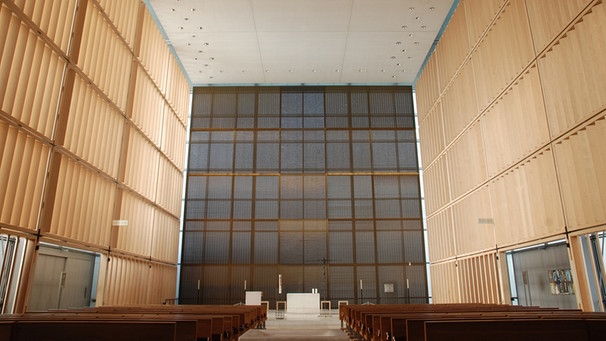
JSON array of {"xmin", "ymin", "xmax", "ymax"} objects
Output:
[{"xmin": 146, "ymin": 0, "xmax": 458, "ymax": 86}]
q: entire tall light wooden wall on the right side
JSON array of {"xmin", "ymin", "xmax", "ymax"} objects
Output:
[{"xmin": 416, "ymin": 0, "xmax": 606, "ymax": 303}]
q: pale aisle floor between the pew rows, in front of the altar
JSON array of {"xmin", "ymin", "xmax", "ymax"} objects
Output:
[{"xmin": 240, "ymin": 310, "xmax": 349, "ymax": 341}]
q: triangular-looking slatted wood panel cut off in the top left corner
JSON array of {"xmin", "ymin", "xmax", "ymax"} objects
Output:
[{"xmin": 14, "ymin": 0, "xmax": 76, "ymax": 53}]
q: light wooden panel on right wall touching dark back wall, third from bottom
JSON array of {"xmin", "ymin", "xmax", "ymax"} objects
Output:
[{"xmin": 423, "ymin": 155, "xmax": 451, "ymax": 216}]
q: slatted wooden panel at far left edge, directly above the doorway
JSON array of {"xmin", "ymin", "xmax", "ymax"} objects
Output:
[{"xmin": 0, "ymin": 120, "xmax": 50, "ymax": 230}]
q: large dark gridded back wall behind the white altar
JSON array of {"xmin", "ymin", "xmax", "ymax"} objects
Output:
[{"xmin": 180, "ymin": 87, "xmax": 427, "ymax": 306}]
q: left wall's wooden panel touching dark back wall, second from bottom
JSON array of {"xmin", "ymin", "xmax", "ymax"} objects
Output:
[{"xmin": 151, "ymin": 210, "xmax": 180, "ymax": 262}]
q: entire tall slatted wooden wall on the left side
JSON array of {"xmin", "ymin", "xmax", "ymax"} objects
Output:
[{"xmin": 0, "ymin": 0, "xmax": 191, "ymax": 309}]
